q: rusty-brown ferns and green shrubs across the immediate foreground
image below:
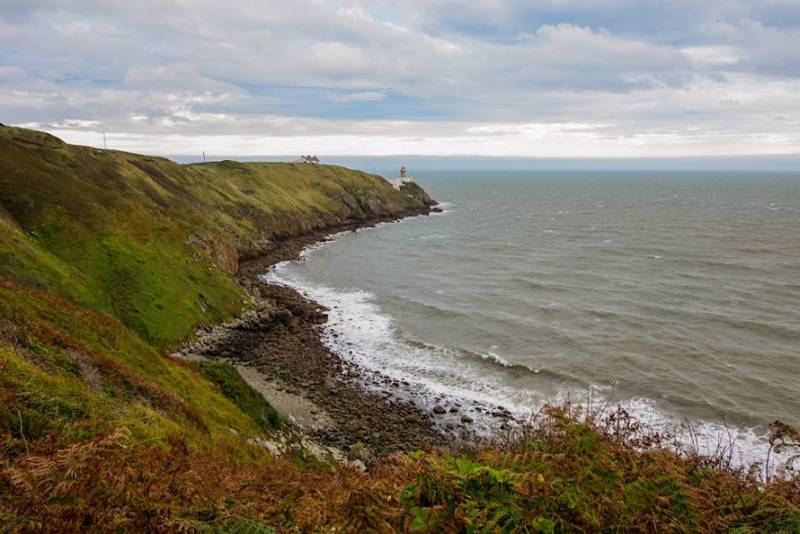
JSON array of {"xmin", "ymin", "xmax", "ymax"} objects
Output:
[{"xmin": 0, "ymin": 408, "xmax": 800, "ymax": 533}]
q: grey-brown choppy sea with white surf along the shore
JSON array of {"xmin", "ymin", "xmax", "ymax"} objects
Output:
[{"xmin": 269, "ymin": 169, "xmax": 800, "ymax": 461}]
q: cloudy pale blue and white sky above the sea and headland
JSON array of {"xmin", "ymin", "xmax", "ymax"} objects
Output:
[{"xmin": 0, "ymin": 0, "xmax": 800, "ymax": 158}]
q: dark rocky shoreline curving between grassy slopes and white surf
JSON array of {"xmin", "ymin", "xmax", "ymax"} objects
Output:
[{"xmin": 179, "ymin": 208, "xmax": 510, "ymax": 464}]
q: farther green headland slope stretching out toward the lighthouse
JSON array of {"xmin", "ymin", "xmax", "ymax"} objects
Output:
[{"xmin": 0, "ymin": 127, "xmax": 432, "ymax": 346}]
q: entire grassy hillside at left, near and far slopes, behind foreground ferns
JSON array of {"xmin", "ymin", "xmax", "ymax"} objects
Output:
[{"xmin": 0, "ymin": 127, "xmax": 429, "ymax": 464}]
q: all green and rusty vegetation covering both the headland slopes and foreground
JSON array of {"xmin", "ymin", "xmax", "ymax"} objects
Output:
[{"xmin": 0, "ymin": 127, "xmax": 800, "ymax": 533}]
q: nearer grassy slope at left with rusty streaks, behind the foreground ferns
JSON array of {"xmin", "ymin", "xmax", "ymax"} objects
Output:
[{"xmin": 0, "ymin": 279, "xmax": 262, "ymax": 456}]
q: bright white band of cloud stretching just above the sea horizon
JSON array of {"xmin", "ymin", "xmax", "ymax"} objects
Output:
[{"xmin": 39, "ymin": 117, "xmax": 800, "ymax": 158}]
